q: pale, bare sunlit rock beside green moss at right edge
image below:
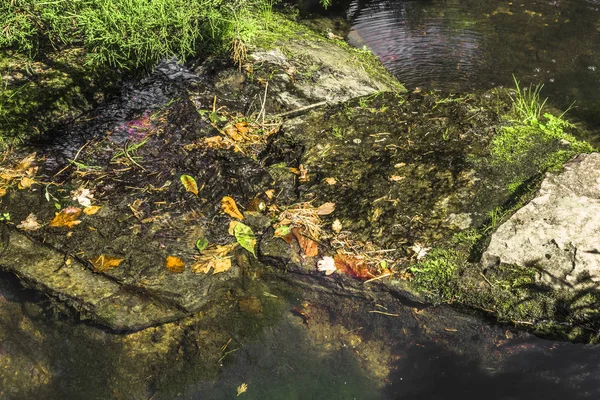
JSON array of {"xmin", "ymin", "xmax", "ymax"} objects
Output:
[{"xmin": 482, "ymin": 153, "xmax": 600, "ymax": 290}]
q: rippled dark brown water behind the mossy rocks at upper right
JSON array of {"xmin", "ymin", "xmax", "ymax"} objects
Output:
[{"xmin": 347, "ymin": 0, "xmax": 600, "ymax": 130}]
